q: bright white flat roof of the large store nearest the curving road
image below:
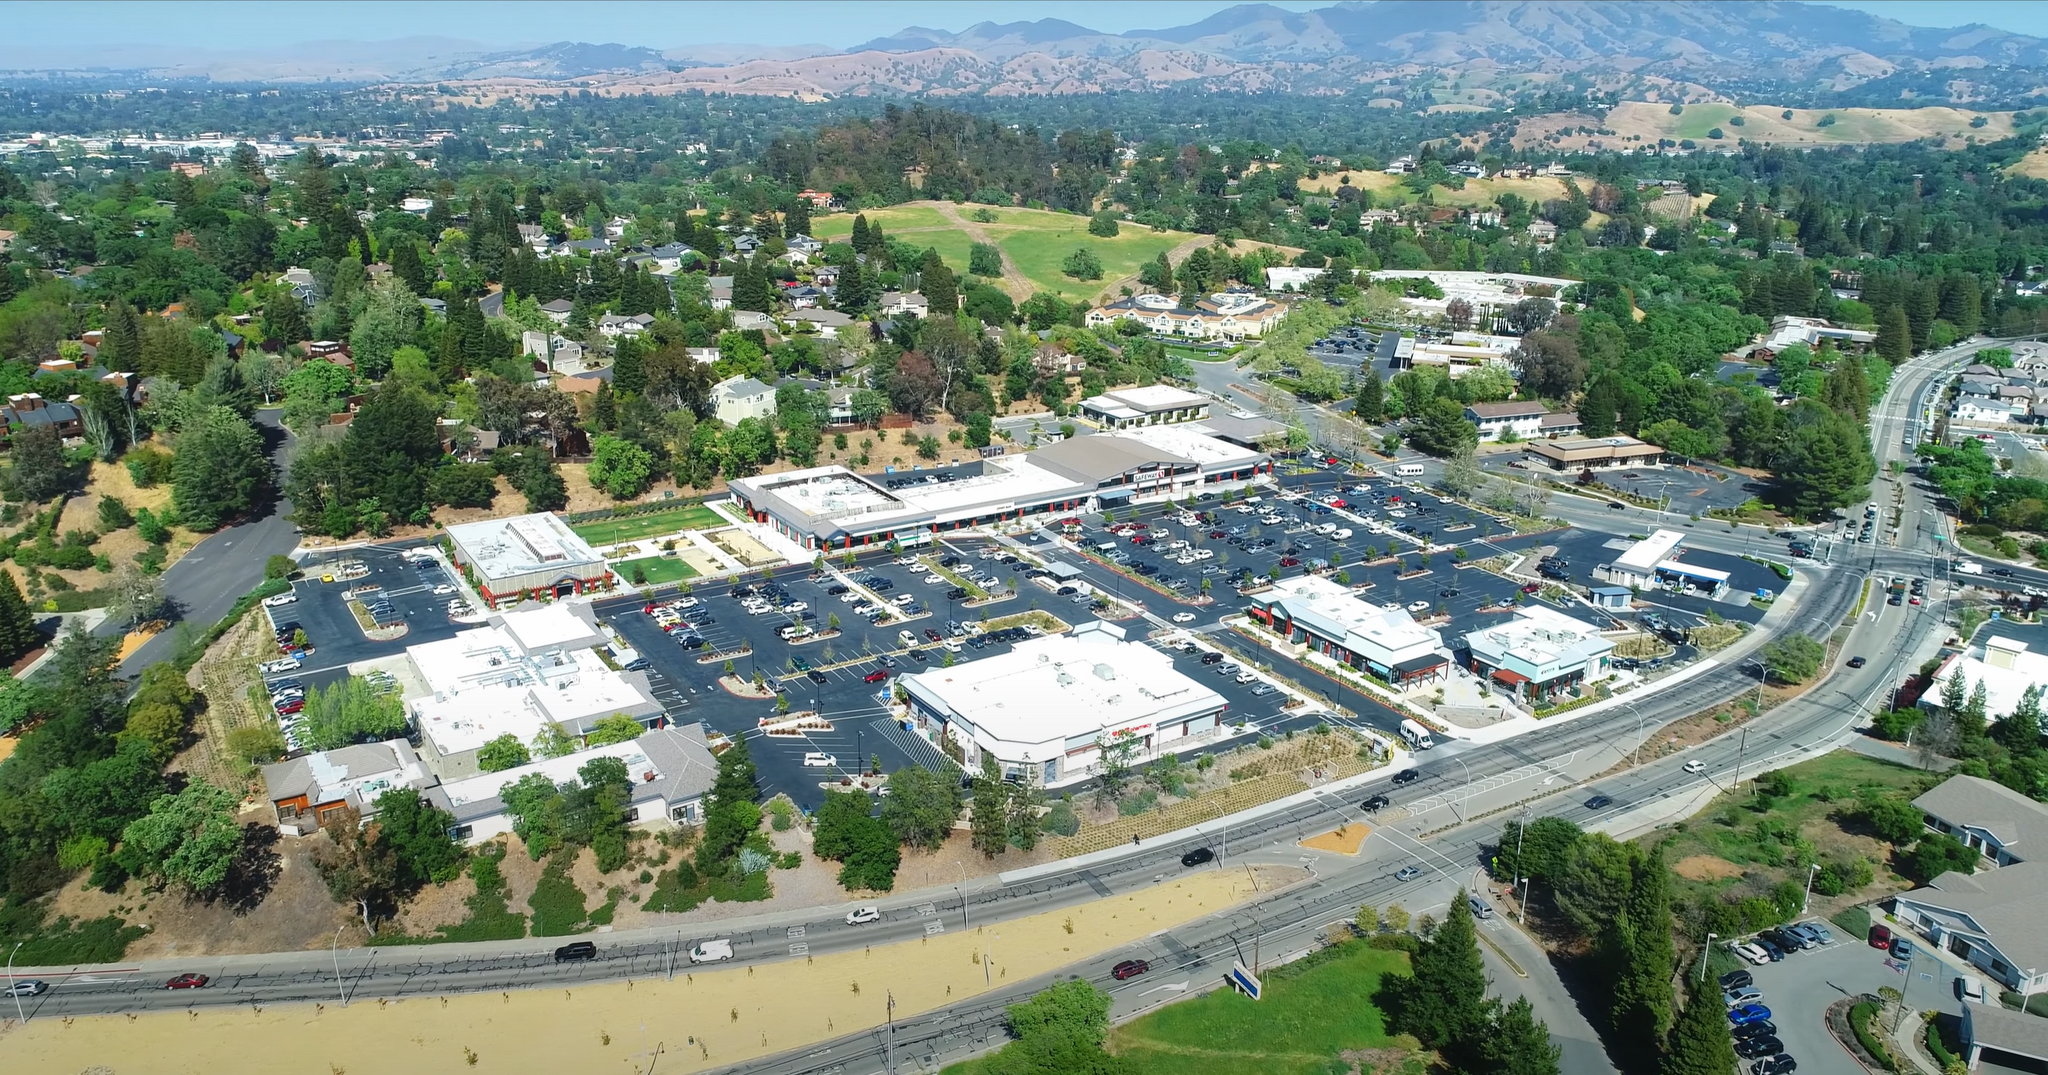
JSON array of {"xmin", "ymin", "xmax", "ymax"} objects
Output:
[{"xmin": 905, "ymin": 625, "xmax": 1225, "ymax": 743}]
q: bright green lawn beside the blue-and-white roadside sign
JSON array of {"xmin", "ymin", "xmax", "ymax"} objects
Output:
[{"xmin": 1110, "ymin": 942, "xmax": 1413, "ymax": 1075}]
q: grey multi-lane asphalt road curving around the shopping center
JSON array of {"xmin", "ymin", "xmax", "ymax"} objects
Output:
[{"xmin": 4, "ymin": 337, "xmax": 2015, "ymax": 1073}]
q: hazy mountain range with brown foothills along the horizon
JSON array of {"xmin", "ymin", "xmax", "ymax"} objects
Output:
[{"xmin": 0, "ymin": 0, "xmax": 2048, "ymax": 104}]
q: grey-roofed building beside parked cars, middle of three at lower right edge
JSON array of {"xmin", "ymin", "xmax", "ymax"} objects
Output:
[{"xmin": 1892, "ymin": 862, "xmax": 2048, "ymax": 999}]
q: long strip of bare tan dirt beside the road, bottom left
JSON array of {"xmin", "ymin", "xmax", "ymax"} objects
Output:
[{"xmin": 6, "ymin": 866, "xmax": 1307, "ymax": 1075}]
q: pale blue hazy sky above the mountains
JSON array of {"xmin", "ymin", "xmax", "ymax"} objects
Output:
[{"xmin": 0, "ymin": 0, "xmax": 2048, "ymax": 63}]
